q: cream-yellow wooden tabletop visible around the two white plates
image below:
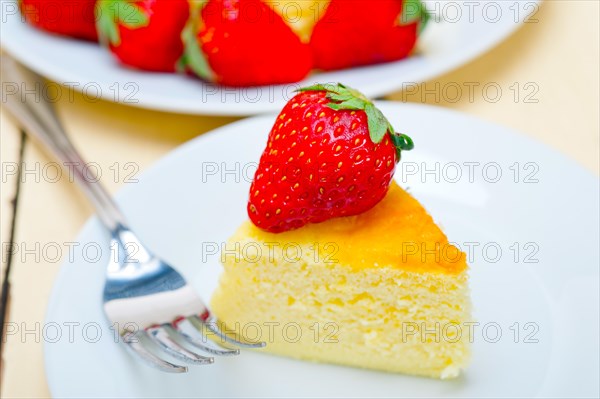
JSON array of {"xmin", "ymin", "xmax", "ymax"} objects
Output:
[{"xmin": 0, "ymin": 0, "xmax": 600, "ymax": 398}]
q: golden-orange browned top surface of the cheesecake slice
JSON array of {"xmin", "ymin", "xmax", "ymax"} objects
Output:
[{"xmin": 233, "ymin": 183, "xmax": 467, "ymax": 274}]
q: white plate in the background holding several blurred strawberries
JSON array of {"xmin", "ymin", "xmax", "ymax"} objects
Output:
[{"xmin": 0, "ymin": 0, "xmax": 538, "ymax": 115}]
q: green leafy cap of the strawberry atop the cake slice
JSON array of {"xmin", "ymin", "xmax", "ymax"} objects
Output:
[{"xmin": 297, "ymin": 83, "xmax": 415, "ymax": 161}]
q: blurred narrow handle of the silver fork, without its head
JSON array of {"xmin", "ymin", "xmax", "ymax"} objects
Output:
[{"xmin": 2, "ymin": 56, "xmax": 126, "ymax": 235}]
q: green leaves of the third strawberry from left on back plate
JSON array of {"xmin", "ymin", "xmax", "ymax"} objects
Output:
[{"xmin": 177, "ymin": 0, "xmax": 216, "ymax": 82}]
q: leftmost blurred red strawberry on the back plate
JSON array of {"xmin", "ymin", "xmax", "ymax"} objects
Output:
[{"xmin": 20, "ymin": 0, "xmax": 98, "ymax": 41}]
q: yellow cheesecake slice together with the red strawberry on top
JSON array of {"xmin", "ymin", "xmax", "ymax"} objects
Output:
[{"xmin": 212, "ymin": 84, "xmax": 471, "ymax": 378}]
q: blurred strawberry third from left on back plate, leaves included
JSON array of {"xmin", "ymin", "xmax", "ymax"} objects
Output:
[{"xmin": 184, "ymin": 0, "xmax": 312, "ymax": 86}]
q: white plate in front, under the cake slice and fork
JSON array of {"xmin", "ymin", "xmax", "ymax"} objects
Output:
[{"xmin": 45, "ymin": 102, "xmax": 599, "ymax": 398}]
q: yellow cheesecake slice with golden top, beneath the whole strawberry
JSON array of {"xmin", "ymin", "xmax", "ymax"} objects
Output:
[{"xmin": 211, "ymin": 183, "xmax": 471, "ymax": 379}]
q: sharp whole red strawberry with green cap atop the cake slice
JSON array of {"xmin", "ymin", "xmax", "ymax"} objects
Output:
[{"xmin": 248, "ymin": 84, "xmax": 413, "ymax": 233}]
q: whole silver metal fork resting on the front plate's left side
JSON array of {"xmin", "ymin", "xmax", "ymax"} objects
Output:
[{"xmin": 2, "ymin": 55, "xmax": 265, "ymax": 373}]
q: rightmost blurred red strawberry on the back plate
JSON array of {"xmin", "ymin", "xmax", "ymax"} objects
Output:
[{"xmin": 311, "ymin": 0, "xmax": 429, "ymax": 70}]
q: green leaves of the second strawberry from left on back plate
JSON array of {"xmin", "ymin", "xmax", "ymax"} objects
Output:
[{"xmin": 96, "ymin": 0, "xmax": 150, "ymax": 47}]
